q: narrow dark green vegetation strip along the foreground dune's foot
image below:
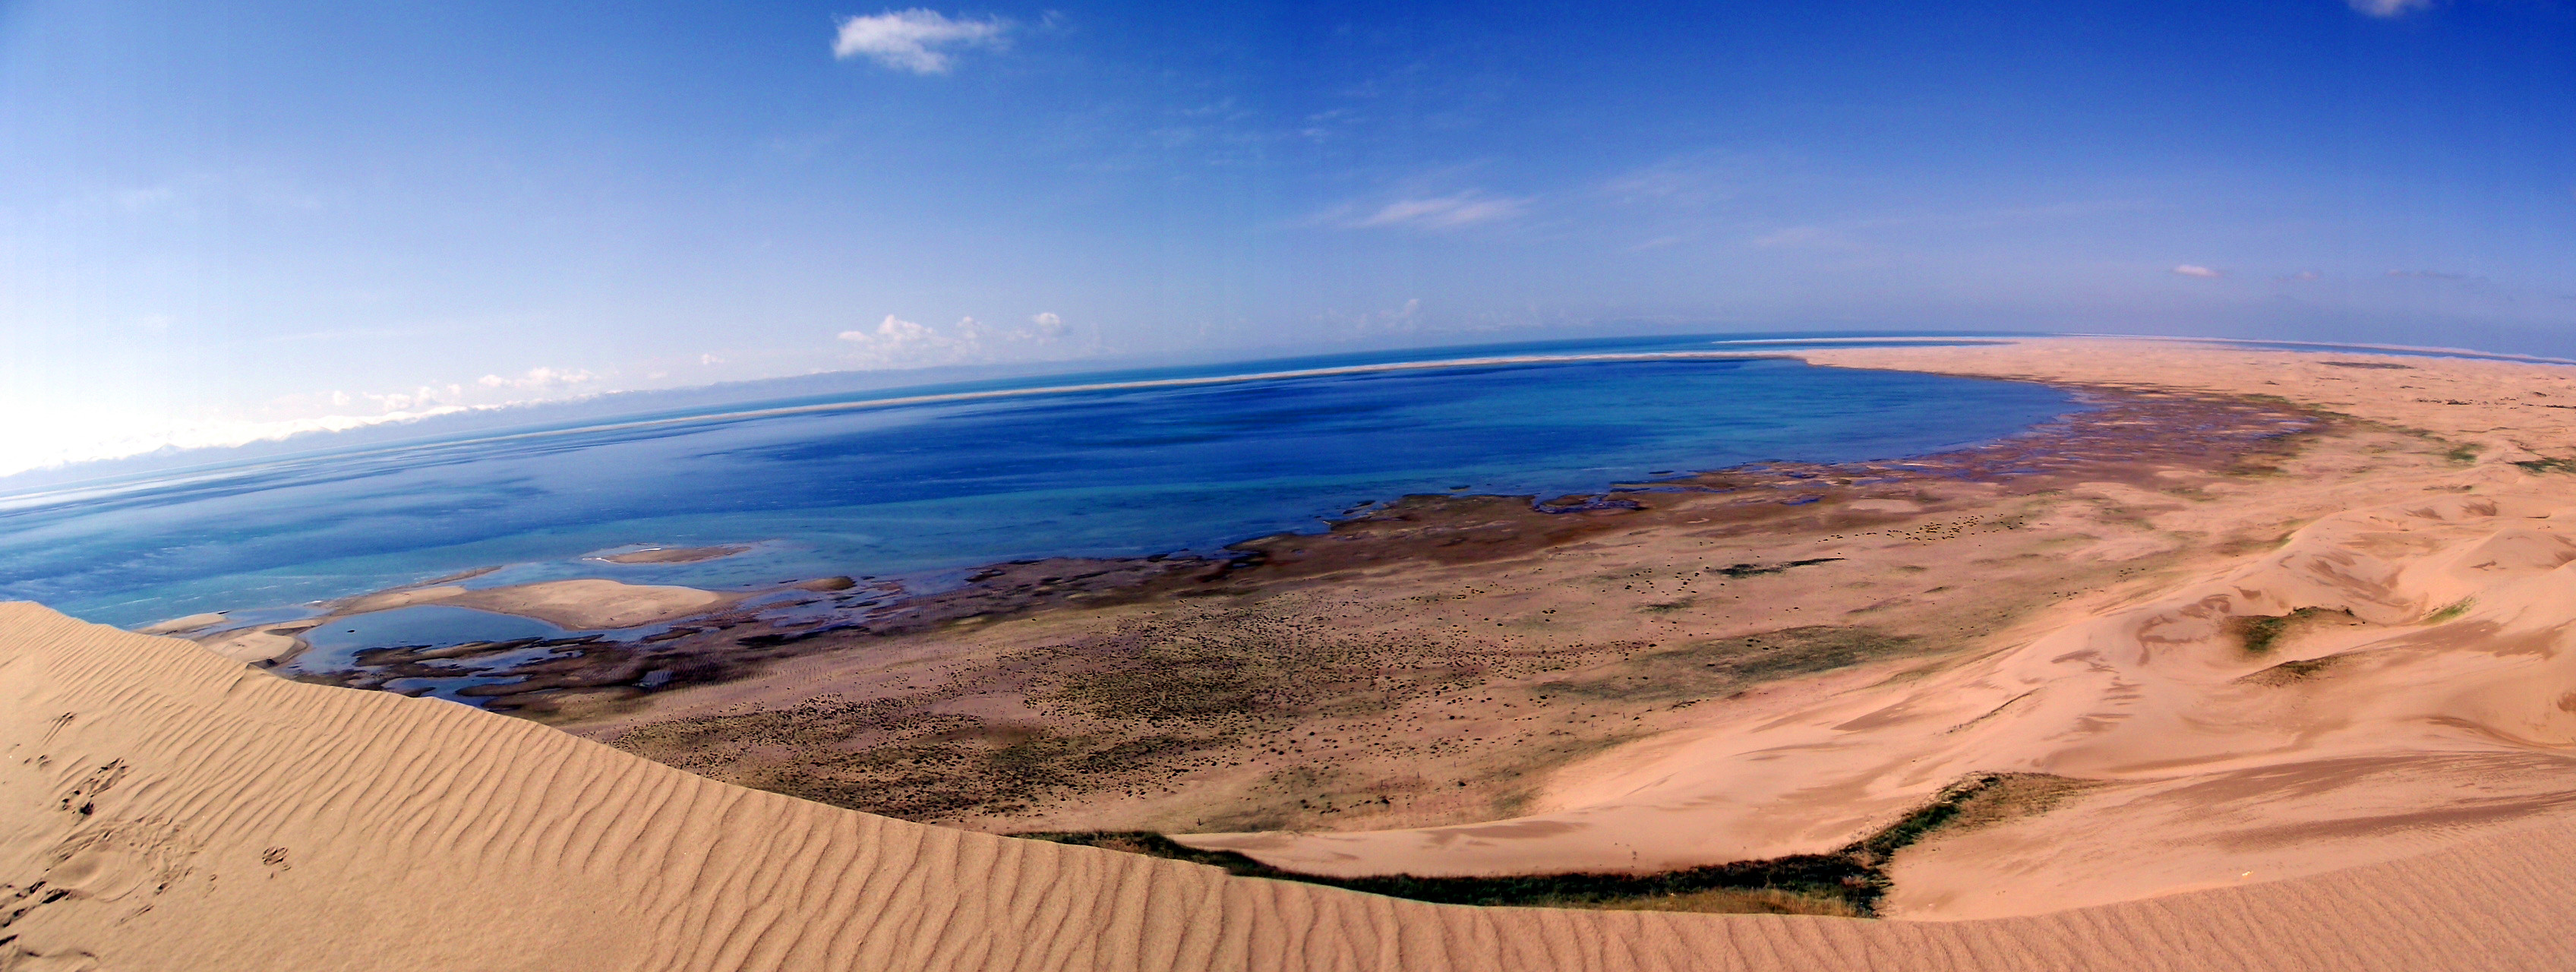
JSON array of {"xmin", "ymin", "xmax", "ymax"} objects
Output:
[{"xmin": 1018, "ymin": 774, "xmax": 2089, "ymax": 918}]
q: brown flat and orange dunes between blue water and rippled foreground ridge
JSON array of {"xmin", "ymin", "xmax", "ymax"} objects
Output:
[{"xmin": 35, "ymin": 340, "xmax": 2576, "ymax": 928}]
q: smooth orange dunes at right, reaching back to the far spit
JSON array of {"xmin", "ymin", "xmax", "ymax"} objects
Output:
[{"xmin": 1188, "ymin": 340, "xmax": 2576, "ymax": 918}]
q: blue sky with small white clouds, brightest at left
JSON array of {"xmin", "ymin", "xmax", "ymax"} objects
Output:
[{"xmin": 0, "ymin": 0, "xmax": 2576, "ymax": 472}]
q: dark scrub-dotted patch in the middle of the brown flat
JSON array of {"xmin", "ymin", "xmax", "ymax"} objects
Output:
[{"xmin": 611, "ymin": 611, "xmax": 1514, "ymax": 822}]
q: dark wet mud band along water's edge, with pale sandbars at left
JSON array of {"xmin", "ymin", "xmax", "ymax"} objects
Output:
[{"xmin": 216, "ymin": 381, "xmax": 2324, "ymax": 712}]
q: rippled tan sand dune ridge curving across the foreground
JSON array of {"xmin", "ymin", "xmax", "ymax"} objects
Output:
[{"xmin": 0, "ymin": 603, "xmax": 2576, "ymax": 972}]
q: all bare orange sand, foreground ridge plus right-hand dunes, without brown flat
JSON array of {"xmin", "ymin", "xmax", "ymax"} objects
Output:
[{"xmin": 0, "ymin": 340, "xmax": 2576, "ymax": 972}]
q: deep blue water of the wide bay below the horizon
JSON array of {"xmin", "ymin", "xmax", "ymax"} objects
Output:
[{"xmin": 0, "ymin": 338, "xmax": 2076, "ymax": 629}]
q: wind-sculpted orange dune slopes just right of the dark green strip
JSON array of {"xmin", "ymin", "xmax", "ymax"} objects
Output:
[{"xmin": 1188, "ymin": 484, "xmax": 2576, "ymax": 892}]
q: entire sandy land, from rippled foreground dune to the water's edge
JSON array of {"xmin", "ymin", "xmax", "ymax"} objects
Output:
[{"xmin": 14, "ymin": 340, "xmax": 2576, "ymax": 970}]
